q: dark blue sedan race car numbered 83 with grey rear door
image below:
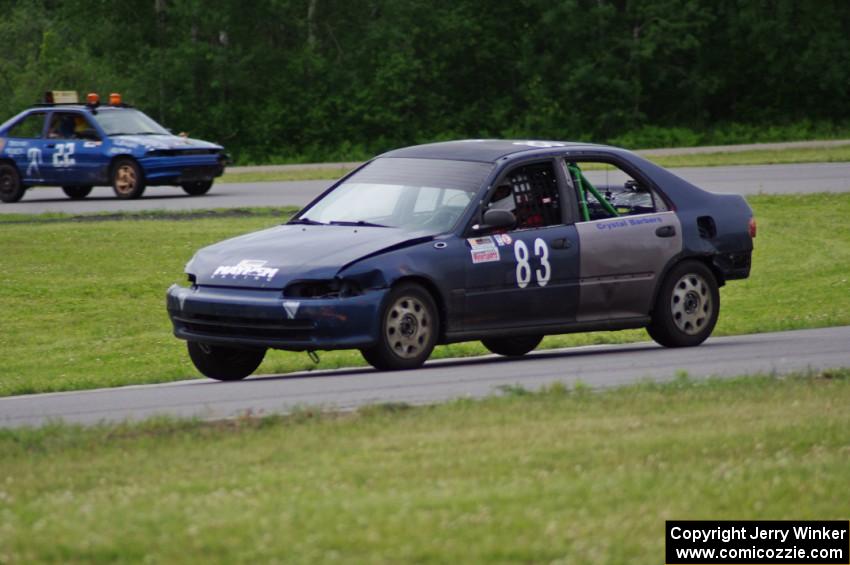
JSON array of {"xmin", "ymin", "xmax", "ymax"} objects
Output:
[{"xmin": 167, "ymin": 140, "xmax": 756, "ymax": 380}]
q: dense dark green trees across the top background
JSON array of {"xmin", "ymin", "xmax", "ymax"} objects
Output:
[{"xmin": 0, "ymin": 0, "xmax": 850, "ymax": 162}]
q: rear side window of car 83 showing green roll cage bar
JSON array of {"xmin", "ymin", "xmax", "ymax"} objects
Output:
[{"xmin": 565, "ymin": 161, "xmax": 668, "ymax": 221}]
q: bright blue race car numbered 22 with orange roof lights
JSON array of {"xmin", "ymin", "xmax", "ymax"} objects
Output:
[{"xmin": 0, "ymin": 92, "xmax": 226, "ymax": 202}]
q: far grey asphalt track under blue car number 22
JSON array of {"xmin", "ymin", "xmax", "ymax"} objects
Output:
[{"xmin": 6, "ymin": 163, "xmax": 850, "ymax": 214}]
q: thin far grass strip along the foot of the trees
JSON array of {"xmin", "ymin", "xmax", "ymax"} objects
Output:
[{"xmin": 219, "ymin": 145, "xmax": 850, "ymax": 183}]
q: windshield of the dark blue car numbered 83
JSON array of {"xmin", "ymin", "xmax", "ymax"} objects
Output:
[{"xmin": 293, "ymin": 157, "xmax": 493, "ymax": 235}]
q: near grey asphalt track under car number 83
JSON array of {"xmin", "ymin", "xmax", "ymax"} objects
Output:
[{"xmin": 0, "ymin": 326, "xmax": 850, "ymax": 427}]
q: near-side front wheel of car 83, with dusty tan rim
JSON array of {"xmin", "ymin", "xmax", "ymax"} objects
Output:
[{"xmin": 360, "ymin": 283, "xmax": 440, "ymax": 371}]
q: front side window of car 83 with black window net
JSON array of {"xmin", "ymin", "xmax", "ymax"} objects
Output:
[{"xmin": 487, "ymin": 162, "xmax": 563, "ymax": 229}]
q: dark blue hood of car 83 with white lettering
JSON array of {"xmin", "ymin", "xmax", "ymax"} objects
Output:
[{"xmin": 186, "ymin": 225, "xmax": 431, "ymax": 289}]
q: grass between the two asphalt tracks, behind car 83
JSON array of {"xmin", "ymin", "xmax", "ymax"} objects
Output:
[{"xmin": 0, "ymin": 194, "xmax": 850, "ymax": 395}]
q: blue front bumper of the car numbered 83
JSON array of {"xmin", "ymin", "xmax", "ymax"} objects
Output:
[{"xmin": 166, "ymin": 285, "xmax": 389, "ymax": 351}]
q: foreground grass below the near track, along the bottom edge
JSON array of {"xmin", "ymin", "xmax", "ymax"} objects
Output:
[{"xmin": 0, "ymin": 370, "xmax": 850, "ymax": 564}]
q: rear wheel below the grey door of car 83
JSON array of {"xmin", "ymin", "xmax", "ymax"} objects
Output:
[{"xmin": 646, "ymin": 261, "xmax": 720, "ymax": 347}]
